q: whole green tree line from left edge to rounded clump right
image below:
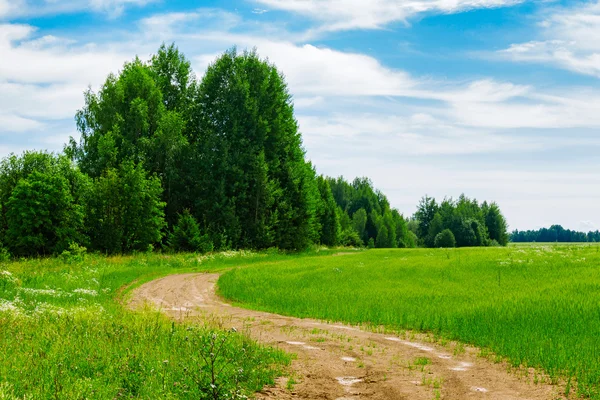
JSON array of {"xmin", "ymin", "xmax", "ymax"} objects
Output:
[{"xmin": 0, "ymin": 45, "xmax": 508, "ymax": 257}]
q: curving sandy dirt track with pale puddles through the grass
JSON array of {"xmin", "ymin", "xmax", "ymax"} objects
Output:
[{"xmin": 130, "ymin": 274, "xmax": 563, "ymax": 400}]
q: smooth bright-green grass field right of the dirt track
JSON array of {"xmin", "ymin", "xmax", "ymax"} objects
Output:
[{"xmin": 219, "ymin": 244, "xmax": 600, "ymax": 399}]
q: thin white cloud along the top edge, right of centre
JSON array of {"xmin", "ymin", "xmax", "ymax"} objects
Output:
[{"xmin": 255, "ymin": 0, "xmax": 523, "ymax": 31}]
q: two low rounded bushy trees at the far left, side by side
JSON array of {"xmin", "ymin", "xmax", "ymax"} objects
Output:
[{"xmin": 0, "ymin": 152, "xmax": 165, "ymax": 256}]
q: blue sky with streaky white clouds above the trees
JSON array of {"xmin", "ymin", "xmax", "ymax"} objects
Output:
[{"xmin": 0, "ymin": 0, "xmax": 600, "ymax": 231}]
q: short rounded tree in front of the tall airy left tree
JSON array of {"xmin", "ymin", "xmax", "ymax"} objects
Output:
[{"xmin": 87, "ymin": 161, "xmax": 165, "ymax": 254}]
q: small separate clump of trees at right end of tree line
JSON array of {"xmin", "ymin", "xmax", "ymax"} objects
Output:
[{"xmin": 409, "ymin": 195, "xmax": 509, "ymax": 247}]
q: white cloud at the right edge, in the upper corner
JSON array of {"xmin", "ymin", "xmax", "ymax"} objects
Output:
[{"xmin": 498, "ymin": 1, "xmax": 600, "ymax": 77}]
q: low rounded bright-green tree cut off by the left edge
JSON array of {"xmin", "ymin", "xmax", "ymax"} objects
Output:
[{"xmin": 0, "ymin": 152, "xmax": 89, "ymax": 256}]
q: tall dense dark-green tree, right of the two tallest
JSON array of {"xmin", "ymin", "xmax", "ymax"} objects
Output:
[{"xmin": 194, "ymin": 49, "xmax": 319, "ymax": 249}]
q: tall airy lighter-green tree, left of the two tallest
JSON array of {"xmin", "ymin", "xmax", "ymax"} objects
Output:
[{"xmin": 67, "ymin": 49, "xmax": 195, "ymax": 223}]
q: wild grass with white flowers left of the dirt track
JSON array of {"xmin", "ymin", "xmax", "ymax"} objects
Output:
[{"xmin": 0, "ymin": 252, "xmax": 338, "ymax": 399}]
